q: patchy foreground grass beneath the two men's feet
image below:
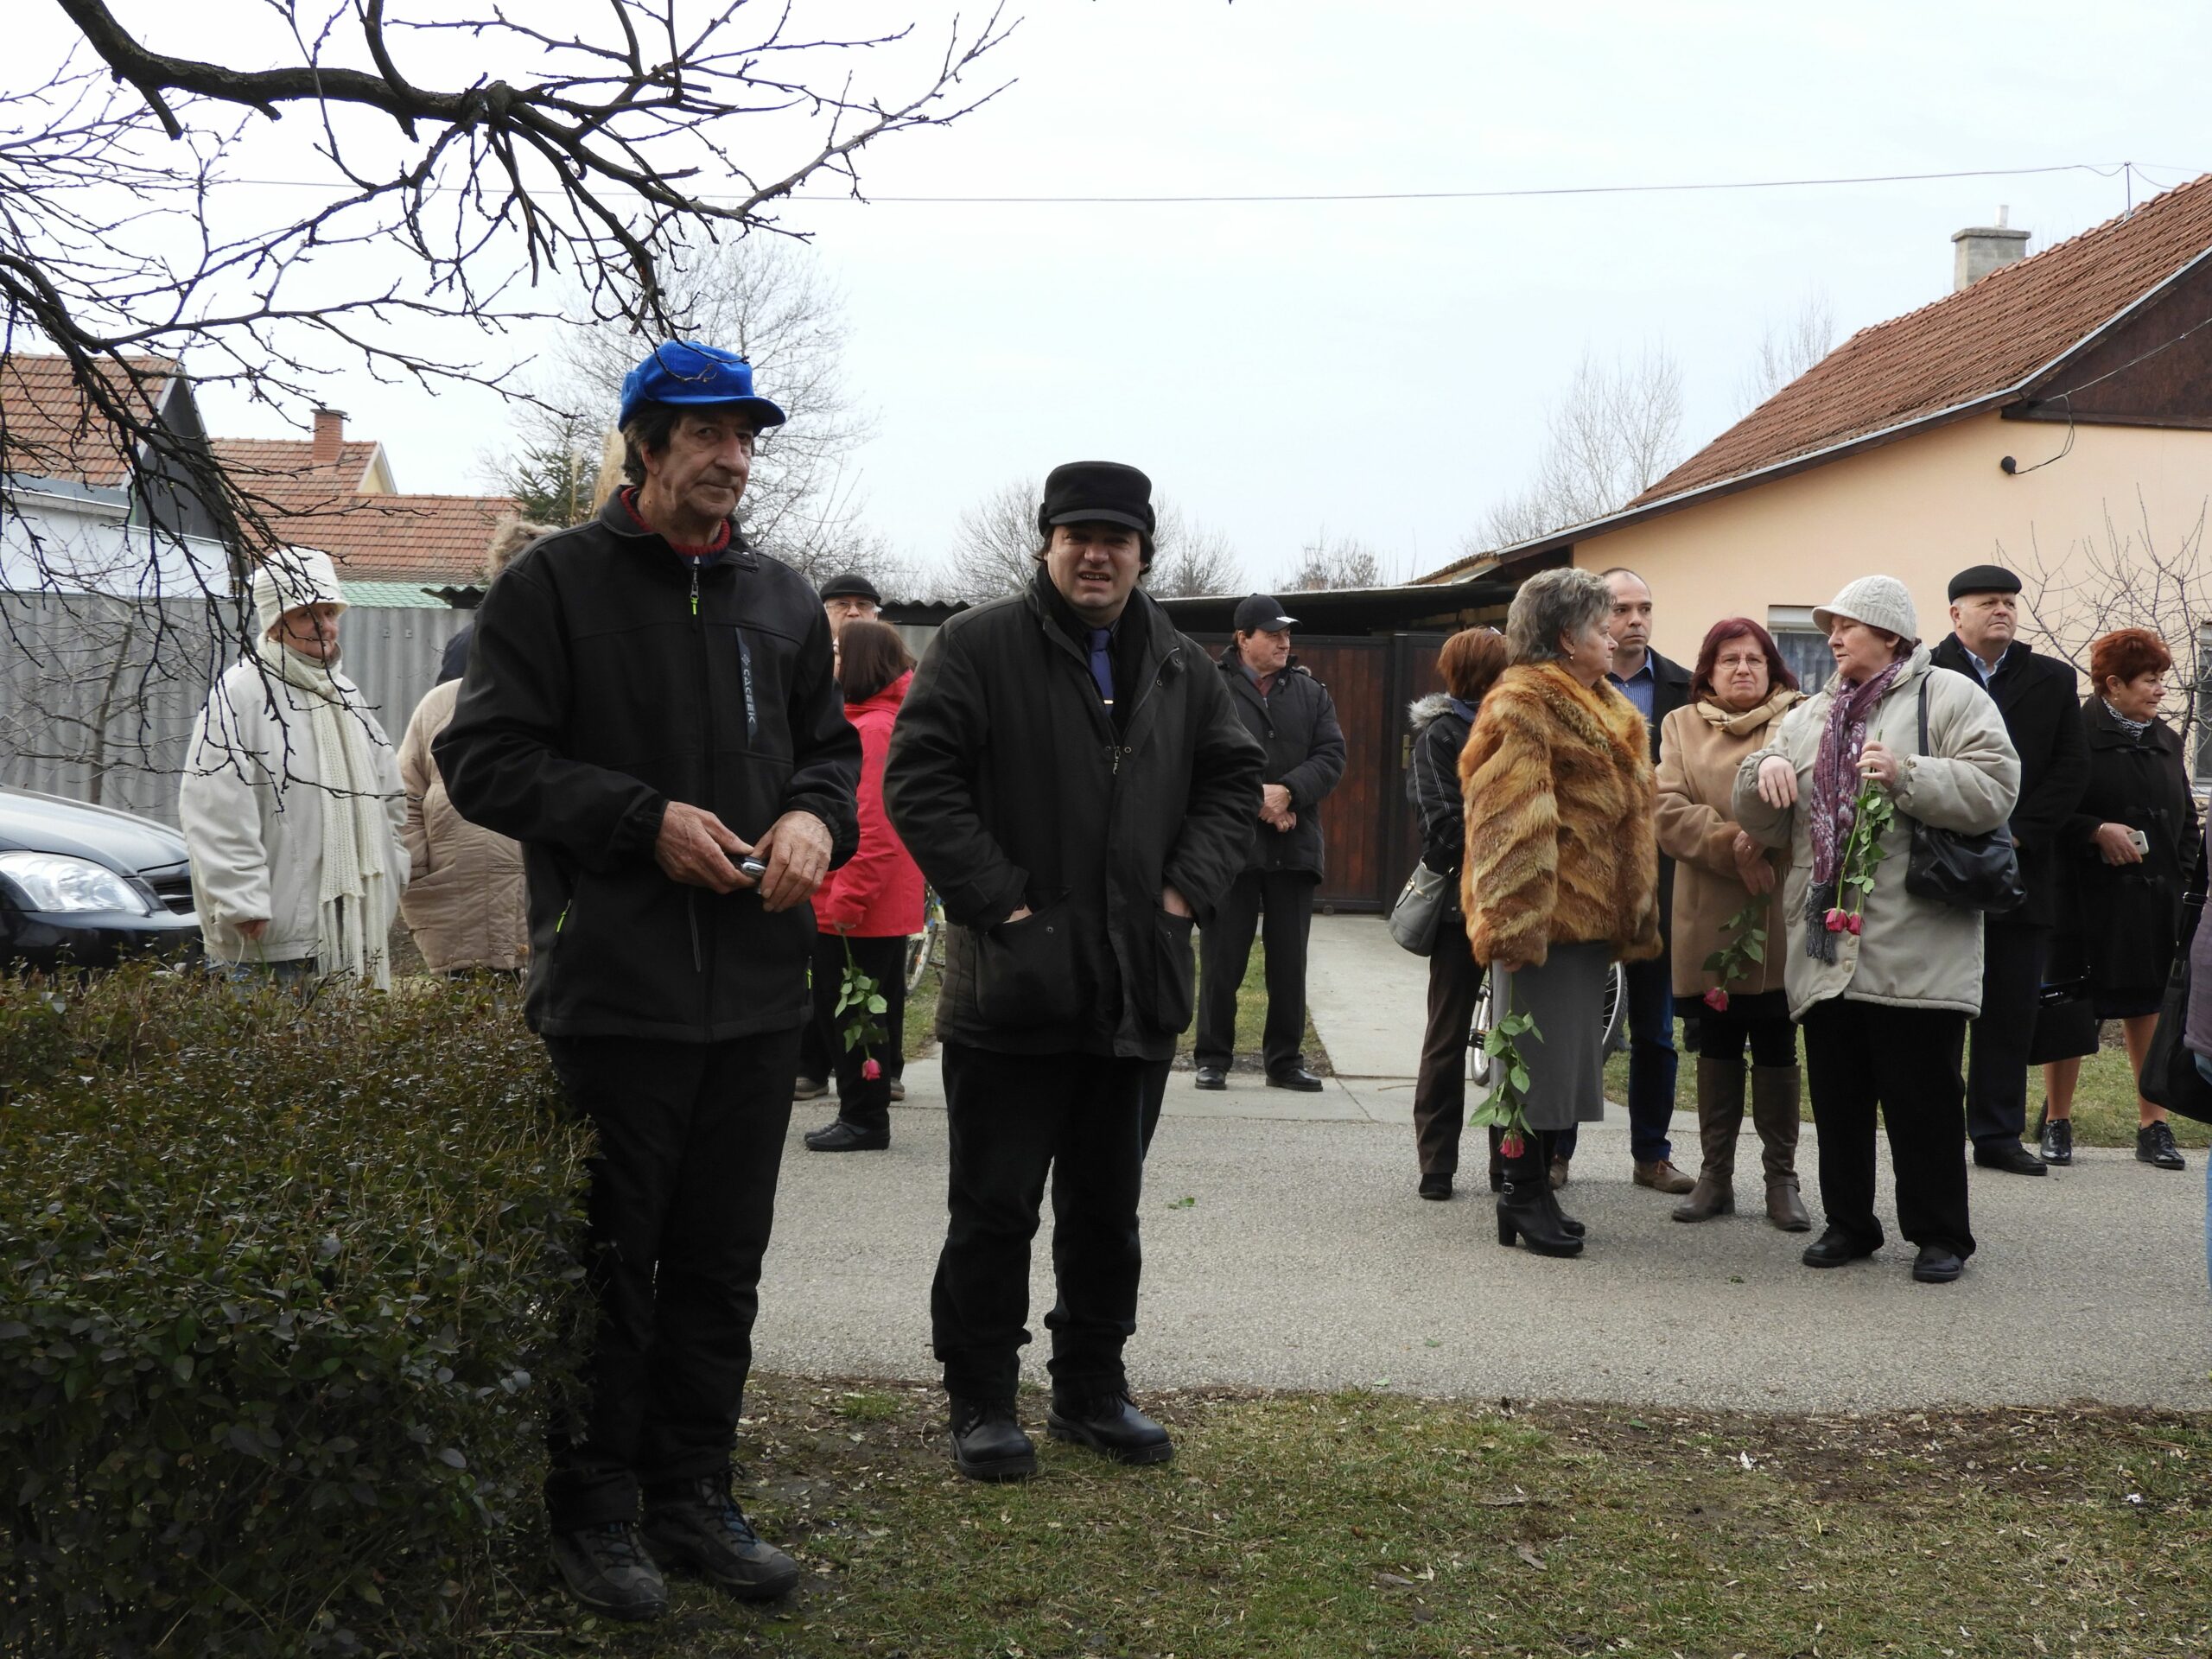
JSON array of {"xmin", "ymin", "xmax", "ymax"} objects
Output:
[{"xmin": 484, "ymin": 1378, "xmax": 2212, "ymax": 1659}]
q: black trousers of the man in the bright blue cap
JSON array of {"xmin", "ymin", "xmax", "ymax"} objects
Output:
[{"xmin": 546, "ymin": 1028, "xmax": 798, "ymax": 1531}]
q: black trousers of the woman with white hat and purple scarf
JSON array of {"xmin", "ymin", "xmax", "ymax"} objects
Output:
[{"xmin": 1805, "ymin": 998, "xmax": 1974, "ymax": 1256}]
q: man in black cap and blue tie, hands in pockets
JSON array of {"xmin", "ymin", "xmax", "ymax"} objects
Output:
[{"xmin": 882, "ymin": 462, "xmax": 1261, "ymax": 1480}]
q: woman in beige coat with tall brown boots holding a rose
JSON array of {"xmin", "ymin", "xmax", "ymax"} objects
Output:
[{"xmin": 1659, "ymin": 617, "xmax": 1812, "ymax": 1232}]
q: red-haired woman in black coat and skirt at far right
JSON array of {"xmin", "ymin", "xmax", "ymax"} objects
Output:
[{"xmin": 2035, "ymin": 628, "xmax": 2199, "ymax": 1170}]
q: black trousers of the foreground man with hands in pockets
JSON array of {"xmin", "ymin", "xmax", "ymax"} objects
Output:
[{"xmin": 929, "ymin": 1042, "xmax": 1166, "ymax": 1400}]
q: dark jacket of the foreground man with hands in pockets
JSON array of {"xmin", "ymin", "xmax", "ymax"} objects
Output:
[{"xmin": 882, "ymin": 573, "xmax": 1263, "ymax": 1059}]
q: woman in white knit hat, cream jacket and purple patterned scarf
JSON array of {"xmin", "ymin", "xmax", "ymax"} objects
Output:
[{"xmin": 1734, "ymin": 575, "xmax": 2019, "ymax": 1283}]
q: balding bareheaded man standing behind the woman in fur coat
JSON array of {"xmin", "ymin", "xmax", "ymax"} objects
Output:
[{"xmin": 1551, "ymin": 569, "xmax": 1697, "ymax": 1192}]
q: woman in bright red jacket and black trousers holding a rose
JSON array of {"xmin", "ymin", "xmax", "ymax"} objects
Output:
[{"xmin": 807, "ymin": 621, "xmax": 923, "ymax": 1153}]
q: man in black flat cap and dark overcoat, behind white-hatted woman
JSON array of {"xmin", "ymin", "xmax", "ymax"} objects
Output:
[{"xmin": 1931, "ymin": 564, "xmax": 2088, "ymax": 1174}]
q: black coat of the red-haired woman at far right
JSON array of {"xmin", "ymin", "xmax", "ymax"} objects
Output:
[{"xmin": 2044, "ymin": 698, "xmax": 2199, "ymax": 1007}]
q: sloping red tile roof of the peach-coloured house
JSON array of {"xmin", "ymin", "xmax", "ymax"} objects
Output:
[{"xmin": 1630, "ymin": 173, "xmax": 2212, "ymax": 506}]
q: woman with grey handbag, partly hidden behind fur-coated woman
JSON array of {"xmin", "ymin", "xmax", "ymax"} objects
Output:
[{"xmin": 1405, "ymin": 628, "xmax": 1506, "ymax": 1199}]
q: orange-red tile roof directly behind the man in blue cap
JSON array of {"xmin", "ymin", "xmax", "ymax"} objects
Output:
[{"xmin": 214, "ymin": 438, "xmax": 520, "ymax": 584}]
